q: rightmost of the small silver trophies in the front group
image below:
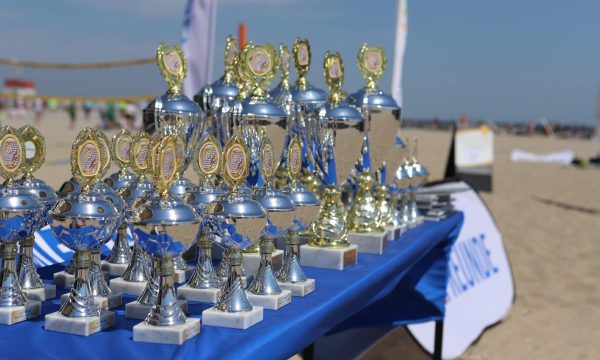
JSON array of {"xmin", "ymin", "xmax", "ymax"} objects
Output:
[{"xmin": 277, "ymin": 135, "xmax": 319, "ymax": 296}]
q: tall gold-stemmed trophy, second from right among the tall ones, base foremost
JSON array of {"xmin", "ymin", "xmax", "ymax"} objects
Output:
[{"xmin": 300, "ymin": 53, "xmax": 364, "ymax": 270}]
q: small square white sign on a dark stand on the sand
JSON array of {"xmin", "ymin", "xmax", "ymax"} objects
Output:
[{"xmin": 454, "ymin": 126, "xmax": 494, "ymax": 168}]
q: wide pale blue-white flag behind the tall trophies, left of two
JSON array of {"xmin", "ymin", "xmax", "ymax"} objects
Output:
[{"xmin": 181, "ymin": 0, "xmax": 217, "ymax": 99}]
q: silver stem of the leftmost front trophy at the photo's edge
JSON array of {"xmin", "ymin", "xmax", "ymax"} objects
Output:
[{"xmin": 0, "ymin": 242, "xmax": 27, "ymax": 307}]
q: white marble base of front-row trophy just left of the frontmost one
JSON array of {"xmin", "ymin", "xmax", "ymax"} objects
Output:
[{"xmin": 44, "ymin": 311, "xmax": 115, "ymax": 336}]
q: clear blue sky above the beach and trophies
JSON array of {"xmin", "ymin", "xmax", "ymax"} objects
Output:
[{"xmin": 0, "ymin": 0, "xmax": 600, "ymax": 125}]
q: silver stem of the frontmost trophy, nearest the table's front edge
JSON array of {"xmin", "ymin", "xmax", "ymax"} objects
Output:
[{"xmin": 146, "ymin": 256, "xmax": 186, "ymax": 326}]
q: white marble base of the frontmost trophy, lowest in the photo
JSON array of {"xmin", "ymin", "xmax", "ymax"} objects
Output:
[{"xmin": 133, "ymin": 318, "xmax": 200, "ymax": 345}]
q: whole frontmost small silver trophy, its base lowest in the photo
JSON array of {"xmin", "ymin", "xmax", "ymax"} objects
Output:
[{"xmin": 132, "ymin": 135, "xmax": 200, "ymax": 345}]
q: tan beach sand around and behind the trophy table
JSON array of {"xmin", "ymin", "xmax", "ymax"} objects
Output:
[{"xmin": 2, "ymin": 112, "xmax": 600, "ymax": 359}]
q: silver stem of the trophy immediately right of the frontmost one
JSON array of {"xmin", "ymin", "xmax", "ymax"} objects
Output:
[{"xmin": 215, "ymin": 249, "xmax": 252, "ymax": 312}]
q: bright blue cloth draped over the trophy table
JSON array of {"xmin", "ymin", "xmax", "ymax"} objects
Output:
[{"xmin": 0, "ymin": 213, "xmax": 463, "ymax": 360}]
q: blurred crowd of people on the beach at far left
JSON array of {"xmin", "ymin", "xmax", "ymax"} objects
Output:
[{"xmin": 0, "ymin": 98, "xmax": 147, "ymax": 130}]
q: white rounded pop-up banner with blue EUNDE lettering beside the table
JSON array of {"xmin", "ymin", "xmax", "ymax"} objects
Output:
[{"xmin": 408, "ymin": 182, "xmax": 515, "ymax": 359}]
